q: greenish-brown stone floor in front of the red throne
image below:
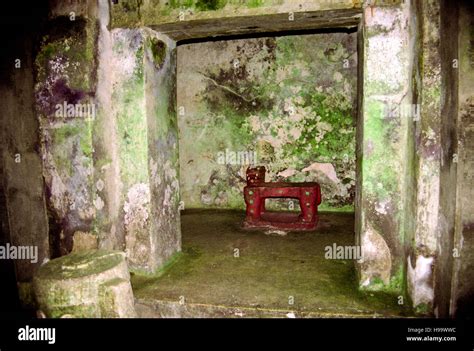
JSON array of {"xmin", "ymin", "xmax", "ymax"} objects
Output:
[{"xmin": 132, "ymin": 210, "xmax": 411, "ymax": 317}]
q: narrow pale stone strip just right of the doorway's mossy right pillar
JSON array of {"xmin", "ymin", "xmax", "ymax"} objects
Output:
[{"xmin": 404, "ymin": 1, "xmax": 441, "ymax": 312}]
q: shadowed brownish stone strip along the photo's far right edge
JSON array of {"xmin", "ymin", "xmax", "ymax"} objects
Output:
[{"xmin": 450, "ymin": 2, "xmax": 474, "ymax": 318}]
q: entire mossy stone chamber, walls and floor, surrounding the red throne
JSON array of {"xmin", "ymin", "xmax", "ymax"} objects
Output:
[{"xmin": 0, "ymin": 0, "xmax": 474, "ymax": 318}]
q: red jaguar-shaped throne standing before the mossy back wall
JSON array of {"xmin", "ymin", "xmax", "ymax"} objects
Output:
[{"xmin": 244, "ymin": 166, "xmax": 321, "ymax": 230}]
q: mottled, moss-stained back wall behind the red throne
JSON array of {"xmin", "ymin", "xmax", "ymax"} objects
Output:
[{"xmin": 177, "ymin": 33, "xmax": 357, "ymax": 208}]
